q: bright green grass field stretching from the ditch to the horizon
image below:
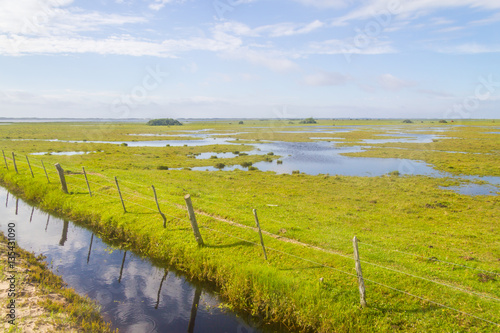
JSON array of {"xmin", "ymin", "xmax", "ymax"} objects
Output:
[{"xmin": 0, "ymin": 120, "xmax": 500, "ymax": 332}]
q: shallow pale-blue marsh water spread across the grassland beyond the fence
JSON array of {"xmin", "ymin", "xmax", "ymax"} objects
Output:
[{"xmin": 29, "ymin": 125, "xmax": 500, "ymax": 195}]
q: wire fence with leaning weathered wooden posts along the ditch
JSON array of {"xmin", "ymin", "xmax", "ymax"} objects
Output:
[{"xmin": 2, "ymin": 150, "xmax": 500, "ymax": 326}]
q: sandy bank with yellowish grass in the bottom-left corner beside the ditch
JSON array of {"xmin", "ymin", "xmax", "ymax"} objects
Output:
[{"xmin": 0, "ymin": 233, "xmax": 111, "ymax": 333}]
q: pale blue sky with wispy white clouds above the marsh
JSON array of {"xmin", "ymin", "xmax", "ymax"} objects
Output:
[{"xmin": 0, "ymin": 0, "xmax": 500, "ymax": 119}]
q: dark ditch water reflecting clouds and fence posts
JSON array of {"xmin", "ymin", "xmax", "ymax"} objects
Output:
[{"xmin": 0, "ymin": 187, "xmax": 268, "ymax": 332}]
